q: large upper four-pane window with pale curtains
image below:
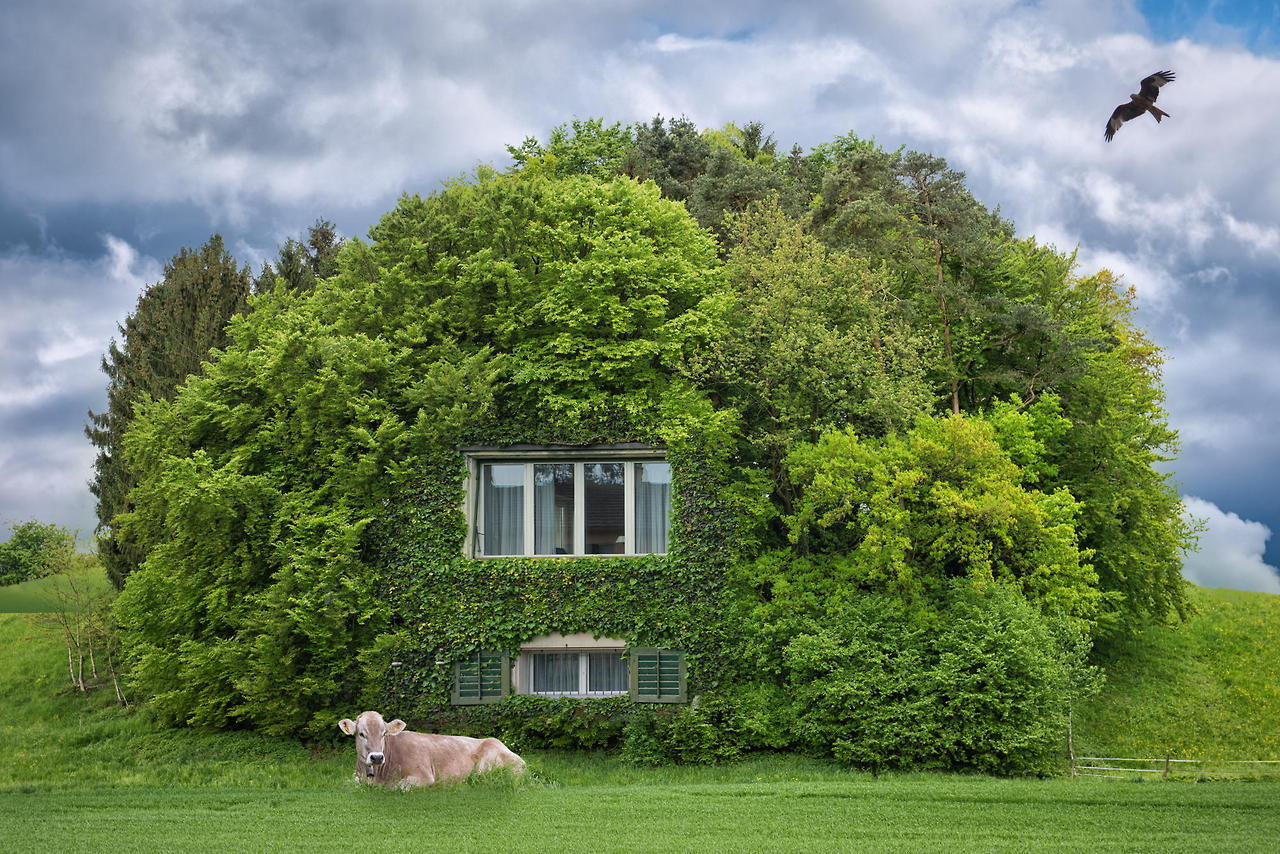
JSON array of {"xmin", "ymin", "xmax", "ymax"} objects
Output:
[{"xmin": 471, "ymin": 453, "xmax": 671, "ymax": 557}]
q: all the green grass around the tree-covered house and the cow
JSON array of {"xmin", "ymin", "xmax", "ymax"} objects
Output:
[{"xmin": 0, "ymin": 571, "xmax": 1280, "ymax": 854}]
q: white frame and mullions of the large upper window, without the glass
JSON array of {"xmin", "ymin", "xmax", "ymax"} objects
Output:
[{"xmin": 463, "ymin": 448, "xmax": 671, "ymax": 558}]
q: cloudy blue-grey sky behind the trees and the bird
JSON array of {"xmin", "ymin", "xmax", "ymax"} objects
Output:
[{"xmin": 0, "ymin": 0, "xmax": 1280, "ymax": 592}]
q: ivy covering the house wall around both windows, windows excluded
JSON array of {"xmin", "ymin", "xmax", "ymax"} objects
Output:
[{"xmin": 369, "ymin": 424, "xmax": 741, "ymax": 745}]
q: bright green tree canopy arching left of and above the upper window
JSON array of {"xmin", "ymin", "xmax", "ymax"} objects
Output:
[{"xmin": 118, "ymin": 173, "xmax": 722, "ymax": 734}]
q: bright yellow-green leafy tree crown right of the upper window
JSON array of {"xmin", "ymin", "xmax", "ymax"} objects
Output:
[{"xmin": 785, "ymin": 412, "xmax": 1100, "ymax": 625}]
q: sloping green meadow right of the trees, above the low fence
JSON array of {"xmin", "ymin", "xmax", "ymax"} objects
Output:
[{"xmin": 1075, "ymin": 588, "xmax": 1280, "ymax": 759}]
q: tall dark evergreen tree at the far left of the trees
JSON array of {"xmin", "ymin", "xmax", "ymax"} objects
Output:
[{"xmin": 84, "ymin": 234, "xmax": 250, "ymax": 586}]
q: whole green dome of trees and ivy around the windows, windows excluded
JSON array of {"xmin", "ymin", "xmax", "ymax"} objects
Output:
[{"xmin": 113, "ymin": 119, "xmax": 1190, "ymax": 773}]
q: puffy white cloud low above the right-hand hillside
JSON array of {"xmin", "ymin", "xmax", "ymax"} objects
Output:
[{"xmin": 1183, "ymin": 495, "xmax": 1280, "ymax": 593}]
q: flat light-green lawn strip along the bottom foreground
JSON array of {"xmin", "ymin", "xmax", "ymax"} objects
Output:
[{"xmin": 0, "ymin": 776, "xmax": 1280, "ymax": 854}]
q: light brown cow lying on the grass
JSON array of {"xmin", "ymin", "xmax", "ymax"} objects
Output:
[{"xmin": 338, "ymin": 712, "xmax": 525, "ymax": 789}]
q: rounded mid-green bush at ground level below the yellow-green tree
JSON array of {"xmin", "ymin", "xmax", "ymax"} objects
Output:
[{"xmin": 782, "ymin": 583, "xmax": 1073, "ymax": 775}]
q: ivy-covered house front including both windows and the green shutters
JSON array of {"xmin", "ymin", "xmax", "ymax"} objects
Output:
[{"xmin": 376, "ymin": 427, "xmax": 731, "ymax": 721}]
